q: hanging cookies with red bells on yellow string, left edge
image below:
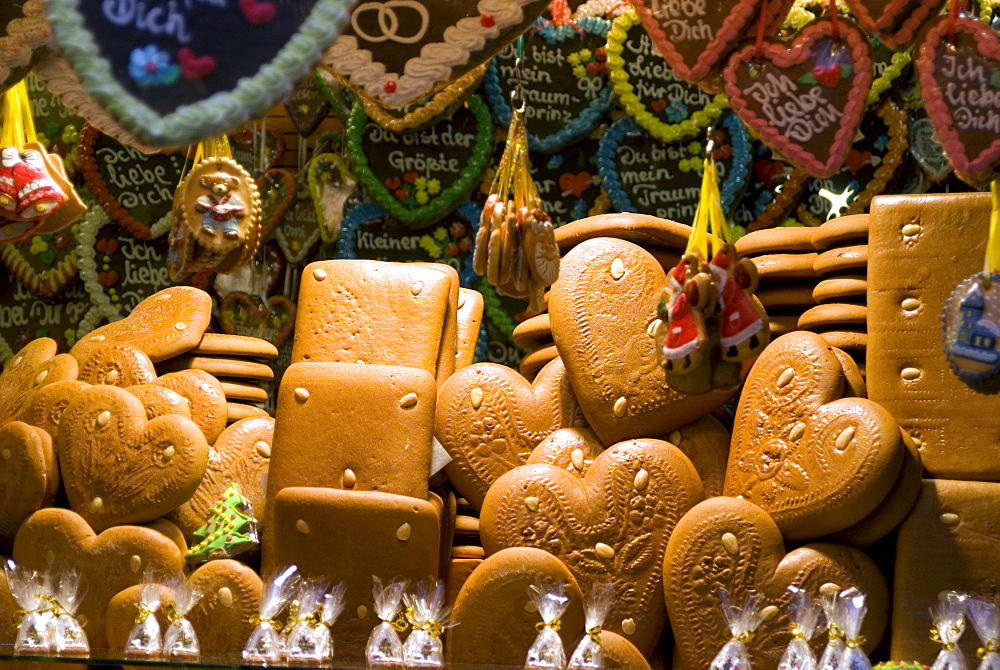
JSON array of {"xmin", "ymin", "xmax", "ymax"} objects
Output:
[{"xmin": 0, "ymin": 81, "xmax": 87, "ymax": 243}]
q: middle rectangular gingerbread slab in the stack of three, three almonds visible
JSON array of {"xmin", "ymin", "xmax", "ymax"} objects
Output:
[{"xmin": 267, "ymin": 363, "xmax": 437, "ymax": 505}]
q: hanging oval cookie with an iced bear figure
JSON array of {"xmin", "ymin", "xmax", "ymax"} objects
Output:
[{"xmin": 167, "ymin": 136, "xmax": 261, "ymax": 281}]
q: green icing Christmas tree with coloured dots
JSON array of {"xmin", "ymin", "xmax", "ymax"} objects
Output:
[{"xmin": 184, "ymin": 484, "xmax": 259, "ymax": 563}]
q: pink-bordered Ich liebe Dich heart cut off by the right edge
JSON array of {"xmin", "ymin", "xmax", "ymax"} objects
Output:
[{"xmin": 916, "ymin": 16, "xmax": 1000, "ymax": 185}]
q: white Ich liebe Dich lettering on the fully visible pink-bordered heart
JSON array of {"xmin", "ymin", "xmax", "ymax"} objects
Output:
[{"xmin": 744, "ymin": 72, "xmax": 842, "ymax": 144}]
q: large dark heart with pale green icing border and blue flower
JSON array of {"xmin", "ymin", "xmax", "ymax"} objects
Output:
[{"xmin": 46, "ymin": 0, "xmax": 346, "ymax": 147}]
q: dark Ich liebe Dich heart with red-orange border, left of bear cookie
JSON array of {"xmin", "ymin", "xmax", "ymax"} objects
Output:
[{"xmin": 78, "ymin": 124, "xmax": 184, "ymax": 240}]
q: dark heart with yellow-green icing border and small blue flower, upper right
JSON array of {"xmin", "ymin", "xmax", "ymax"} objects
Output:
[{"xmin": 607, "ymin": 10, "xmax": 729, "ymax": 142}]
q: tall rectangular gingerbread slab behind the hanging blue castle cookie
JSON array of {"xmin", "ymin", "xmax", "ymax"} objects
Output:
[{"xmin": 867, "ymin": 193, "xmax": 1000, "ymax": 481}]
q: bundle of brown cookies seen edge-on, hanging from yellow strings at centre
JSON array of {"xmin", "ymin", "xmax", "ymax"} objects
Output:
[{"xmin": 473, "ymin": 40, "xmax": 559, "ymax": 315}]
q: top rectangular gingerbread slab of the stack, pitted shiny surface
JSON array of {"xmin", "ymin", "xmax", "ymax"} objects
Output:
[{"xmin": 292, "ymin": 260, "xmax": 458, "ymax": 375}]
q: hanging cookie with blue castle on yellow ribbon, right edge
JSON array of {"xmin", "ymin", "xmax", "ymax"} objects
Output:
[{"xmin": 941, "ymin": 181, "xmax": 1000, "ymax": 394}]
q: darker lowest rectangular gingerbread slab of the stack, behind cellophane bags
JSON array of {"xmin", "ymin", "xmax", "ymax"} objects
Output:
[{"xmin": 261, "ymin": 488, "xmax": 441, "ymax": 659}]
